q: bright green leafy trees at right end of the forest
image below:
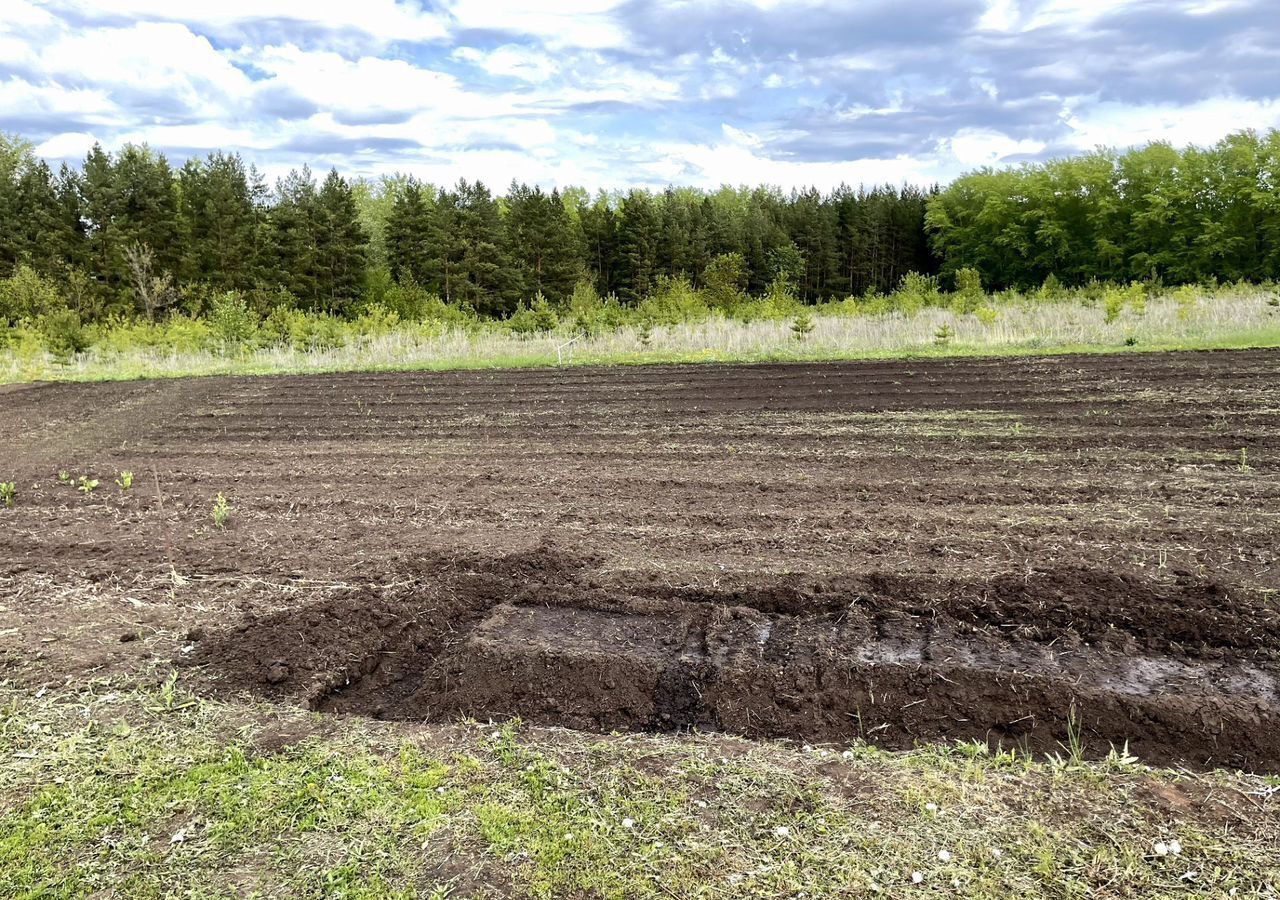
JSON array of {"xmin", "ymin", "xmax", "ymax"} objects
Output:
[{"xmin": 925, "ymin": 129, "xmax": 1280, "ymax": 288}]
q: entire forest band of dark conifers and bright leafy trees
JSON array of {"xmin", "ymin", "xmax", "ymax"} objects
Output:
[{"xmin": 0, "ymin": 131, "xmax": 1280, "ymax": 337}]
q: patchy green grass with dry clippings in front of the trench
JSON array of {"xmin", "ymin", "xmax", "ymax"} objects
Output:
[{"xmin": 0, "ymin": 676, "xmax": 1280, "ymax": 897}]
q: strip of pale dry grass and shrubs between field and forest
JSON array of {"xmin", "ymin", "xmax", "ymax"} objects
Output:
[{"xmin": 0, "ymin": 287, "xmax": 1280, "ymax": 383}]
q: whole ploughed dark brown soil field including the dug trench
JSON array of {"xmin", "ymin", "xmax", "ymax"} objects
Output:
[{"xmin": 0, "ymin": 352, "xmax": 1280, "ymax": 771}]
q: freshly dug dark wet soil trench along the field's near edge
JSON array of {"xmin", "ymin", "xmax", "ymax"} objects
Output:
[{"xmin": 186, "ymin": 559, "xmax": 1280, "ymax": 771}]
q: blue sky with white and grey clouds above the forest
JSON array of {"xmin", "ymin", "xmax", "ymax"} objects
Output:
[{"xmin": 0, "ymin": 0, "xmax": 1280, "ymax": 189}]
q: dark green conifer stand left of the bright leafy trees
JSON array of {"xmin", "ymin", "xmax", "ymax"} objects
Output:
[{"xmin": 0, "ymin": 137, "xmax": 938, "ymax": 320}]
